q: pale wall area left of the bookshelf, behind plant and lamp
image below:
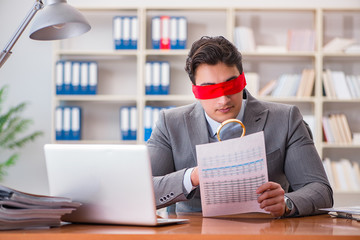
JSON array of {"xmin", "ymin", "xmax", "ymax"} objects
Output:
[{"xmin": 0, "ymin": 0, "xmax": 52, "ymax": 194}]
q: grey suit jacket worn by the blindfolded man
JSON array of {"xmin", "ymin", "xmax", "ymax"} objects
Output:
[{"xmin": 147, "ymin": 90, "xmax": 333, "ymax": 216}]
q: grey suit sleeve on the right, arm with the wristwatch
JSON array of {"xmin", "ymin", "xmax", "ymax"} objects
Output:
[{"xmin": 284, "ymin": 107, "xmax": 333, "ymax": 216}]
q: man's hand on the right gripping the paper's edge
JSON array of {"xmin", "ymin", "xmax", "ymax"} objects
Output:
[{"xmin": 256, "ymin": 182, "xmax": 285, "ymax": 217}]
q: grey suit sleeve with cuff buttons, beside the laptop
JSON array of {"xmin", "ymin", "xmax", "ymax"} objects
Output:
[{"xmin": 147, "ymin": 111, "xmax": 187, "ymax": 208}]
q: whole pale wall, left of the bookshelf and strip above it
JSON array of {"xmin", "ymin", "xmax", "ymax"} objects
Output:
[{"xmin": 0, "ymin": 0, "xmax": 360, "ymax": 194}]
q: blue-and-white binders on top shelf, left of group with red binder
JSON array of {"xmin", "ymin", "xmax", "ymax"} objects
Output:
[{"xmin": 113, "ymin": 16, "xmax": 139, "ymax": 50}]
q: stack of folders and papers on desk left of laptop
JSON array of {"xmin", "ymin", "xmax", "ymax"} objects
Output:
[{"xmin": 0, "ymin": 185, "xmax": 81, "ymax": 230}]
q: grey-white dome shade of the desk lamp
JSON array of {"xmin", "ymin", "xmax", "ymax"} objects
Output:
[{"xmin": 30, "ymin": 0, "xmax": 91, "ymax": 40}]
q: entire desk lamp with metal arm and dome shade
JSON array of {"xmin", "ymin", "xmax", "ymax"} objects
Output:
[{"xmin": 0, "ymin": 0, "xmax": 91, "ymax": 68}]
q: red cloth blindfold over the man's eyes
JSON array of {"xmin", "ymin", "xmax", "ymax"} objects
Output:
[{"xmin": 192, "ymin": 73, "xmax": 246, "ymax": 99}]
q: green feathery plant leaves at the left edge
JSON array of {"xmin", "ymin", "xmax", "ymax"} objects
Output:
[{"xmin": 0, "ymin": 86, "xmax": 42, "ymax": 181}]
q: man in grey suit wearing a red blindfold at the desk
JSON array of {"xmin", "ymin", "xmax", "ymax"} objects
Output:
[{"xmin": 147, "ymin": 37, "xmax": 333, "ymax": 217}]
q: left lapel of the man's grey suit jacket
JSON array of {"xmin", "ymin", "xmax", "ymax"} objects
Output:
[{"xmin": 184, "ymin": 102, "xmax": 209, "ymax": 164}]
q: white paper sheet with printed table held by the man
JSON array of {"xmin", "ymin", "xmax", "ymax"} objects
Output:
[{"xmin": 196, "ymin": 132, "xmax": 268, "ymax": 217}]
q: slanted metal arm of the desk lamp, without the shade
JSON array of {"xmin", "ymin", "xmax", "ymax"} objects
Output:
[{"xmin": 0, "ymin": 0, "xmax": 44, "ymax": 68}]
